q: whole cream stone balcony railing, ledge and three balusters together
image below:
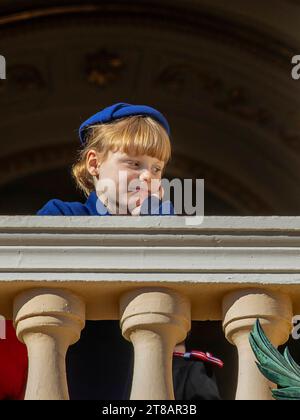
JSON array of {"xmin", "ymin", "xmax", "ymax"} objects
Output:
[{"xmin": 0, "ymin": 216, "xmax": 300, "ymax": 400}]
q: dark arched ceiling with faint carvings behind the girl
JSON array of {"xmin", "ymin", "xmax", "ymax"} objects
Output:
[{"xmin": 0, "ymin": 0, "xmax": 300, "ymax": 214}]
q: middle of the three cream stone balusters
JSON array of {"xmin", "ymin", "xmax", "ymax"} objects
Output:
[{"xmin": 120, "ymin": 288, "xmax": 191, "ymax": 400}]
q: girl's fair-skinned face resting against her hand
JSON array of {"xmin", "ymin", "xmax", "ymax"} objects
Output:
[{"xmin": 96, "ymin": 151, "xmax": 165, "ymax": 214}]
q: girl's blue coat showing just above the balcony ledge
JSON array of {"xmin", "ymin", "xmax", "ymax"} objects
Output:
[{"xmin": 37, "ymin": 191, "xmax": 175, "ymax": 216}]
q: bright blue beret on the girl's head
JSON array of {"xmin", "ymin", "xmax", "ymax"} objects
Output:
[{"xmin": 79, "ymin": 103, "xmax": 170, "ymax": 145}]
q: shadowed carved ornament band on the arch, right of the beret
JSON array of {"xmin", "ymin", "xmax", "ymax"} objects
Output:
[{"xmin": 153, "ymin": 62, "xmax": 300, "ymax": 157}]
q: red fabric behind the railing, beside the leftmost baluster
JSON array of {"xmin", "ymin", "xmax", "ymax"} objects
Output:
[{"xmin": 0, "ymin": 321, "xmax": 28, "ymax": 400}]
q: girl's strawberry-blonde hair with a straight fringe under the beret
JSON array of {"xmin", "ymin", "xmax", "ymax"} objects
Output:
[{"xmin": 72, "ymin": 115, "xmax": 171, "ymax": 196}]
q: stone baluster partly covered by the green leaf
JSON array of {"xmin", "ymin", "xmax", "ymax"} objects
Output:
[{"xmin": 223, "ymin": 289, "xmax": 293, "ymax": 400}]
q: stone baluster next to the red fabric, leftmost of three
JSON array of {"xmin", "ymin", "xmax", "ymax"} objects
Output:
[{"xmin": 14, "ymin": 289, "xmax": 85, "ymax": 400}]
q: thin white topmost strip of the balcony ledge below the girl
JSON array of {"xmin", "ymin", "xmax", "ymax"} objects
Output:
[{"xmin": 0, "ymin": 216, "xmax": 300, "ymax": 236}]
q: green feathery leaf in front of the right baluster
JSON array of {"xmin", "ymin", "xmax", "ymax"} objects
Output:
[{"xmin": 249, "ymin": 319, "xmax": 300, "ymax": 400}]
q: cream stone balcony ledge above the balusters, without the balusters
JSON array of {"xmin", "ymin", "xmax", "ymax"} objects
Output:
[{"xmin": 0, "ymin": 216, "xmax": 300, "ymax": 320}]
